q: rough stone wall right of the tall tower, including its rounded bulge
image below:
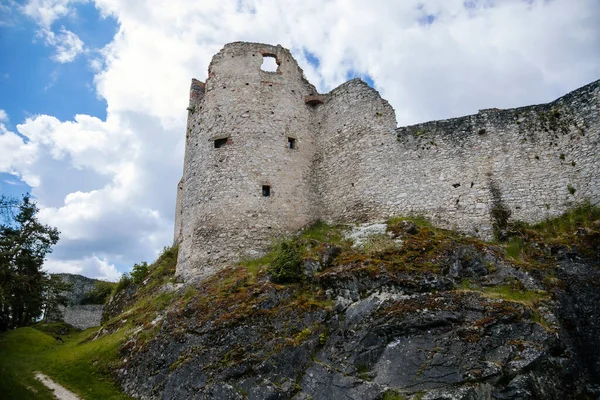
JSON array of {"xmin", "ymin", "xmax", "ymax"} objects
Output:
[{"xmin": 316, "ymin": 80, "xmax": 600, "ymax": 238}]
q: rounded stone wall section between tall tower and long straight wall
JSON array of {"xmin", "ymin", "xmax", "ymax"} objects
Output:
[{"xmin": 315, "ymin": 79, "xmax": 397, "ymax": 222}]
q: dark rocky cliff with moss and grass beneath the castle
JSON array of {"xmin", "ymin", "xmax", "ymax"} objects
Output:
[{"xmin": 113, "ymin": 209, "xmax": 600, "ymax": 399}]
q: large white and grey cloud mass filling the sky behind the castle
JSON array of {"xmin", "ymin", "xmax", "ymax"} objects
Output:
[{"xmin": 0, "ymin": 0, "xmax": 600, "ymax": 278}]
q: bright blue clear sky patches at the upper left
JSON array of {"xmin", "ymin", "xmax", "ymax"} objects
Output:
[{"xmin": 0, "ymin": 2, "xmax": 118, "ymax": 197}]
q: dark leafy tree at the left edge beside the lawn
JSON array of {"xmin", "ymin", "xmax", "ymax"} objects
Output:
[{"xmin": 0, "ymin": 194, "xmax": 59, "ymax": 327}]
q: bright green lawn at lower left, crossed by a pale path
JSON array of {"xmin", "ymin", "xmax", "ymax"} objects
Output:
[{"xmin": 0, "ymin": 324, "xmax": 129, "ymax": 400}]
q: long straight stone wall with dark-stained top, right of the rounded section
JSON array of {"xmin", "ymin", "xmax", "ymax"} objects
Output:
[{"xmin": 382, "ymin": 82, "xmax": 600, "ymax": 238}]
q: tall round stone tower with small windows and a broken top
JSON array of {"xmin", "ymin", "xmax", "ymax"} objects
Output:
[{"xmin": 176, "ymin": 43, "xmax": 316, "ymax": 279}]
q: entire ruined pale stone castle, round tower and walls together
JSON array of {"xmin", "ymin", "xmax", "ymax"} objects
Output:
[{"xmin": 175, "ymin": 42, "xmax": 600, "ymax": 280}]
